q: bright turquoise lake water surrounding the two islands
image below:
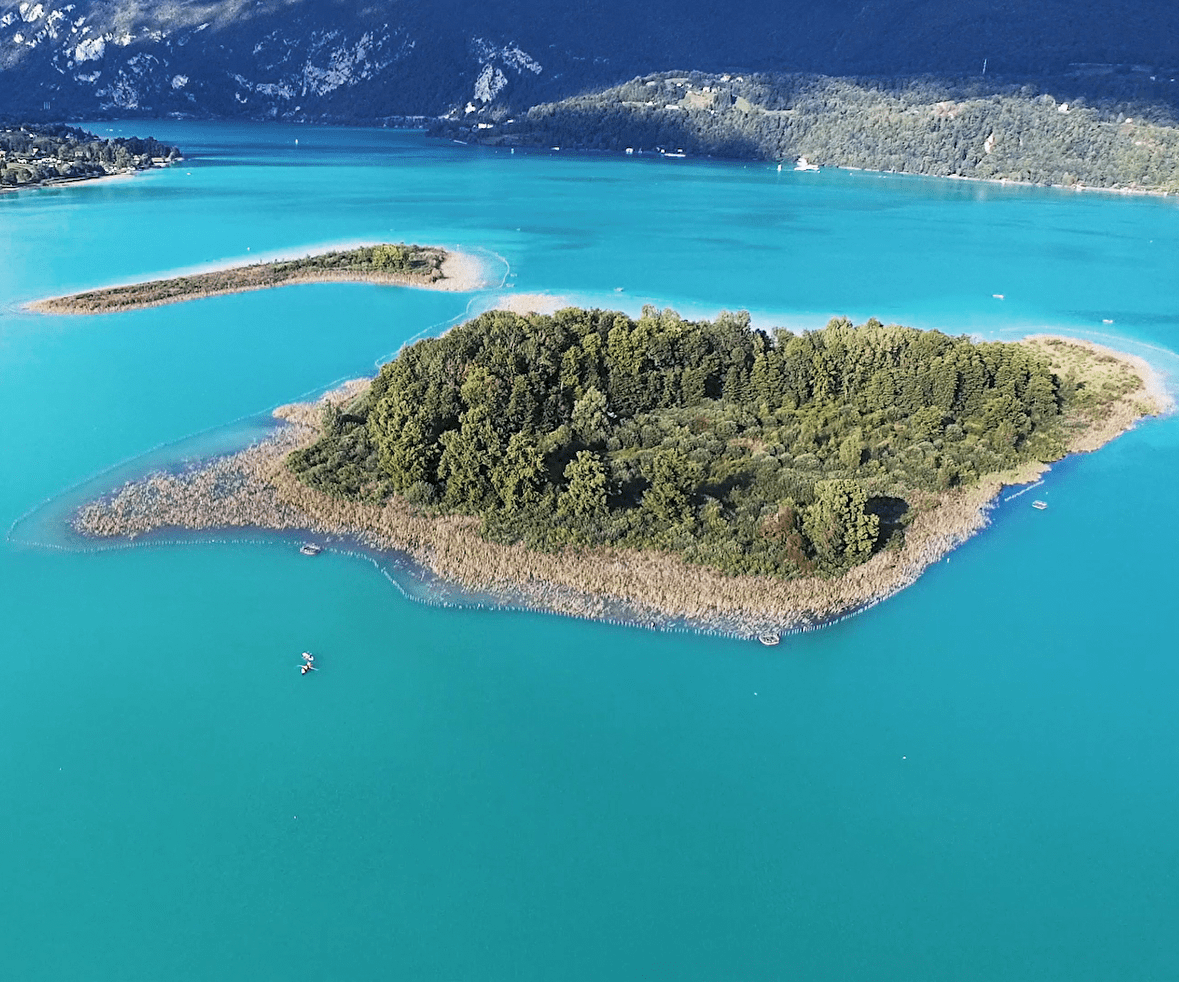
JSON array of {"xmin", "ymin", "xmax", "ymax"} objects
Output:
[{"xmin": 0, "ymin": 123, "xmax": 1179, "ymax": 982}]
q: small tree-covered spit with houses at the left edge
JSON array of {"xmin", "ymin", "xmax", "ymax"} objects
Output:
[{"xmin": 0, "ymin": 124, "xmax": 180, "ymax": 191}]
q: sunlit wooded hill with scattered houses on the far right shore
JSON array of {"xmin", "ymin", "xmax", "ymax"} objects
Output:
[{"xmin": 434, "ymin": 72, "xmax": 1179, "ymax": 192}]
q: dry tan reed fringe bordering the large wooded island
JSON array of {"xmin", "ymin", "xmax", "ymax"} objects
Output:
[{"xmin": 74, "ymin": 332, "xmax": 1172, "ymax": 638}]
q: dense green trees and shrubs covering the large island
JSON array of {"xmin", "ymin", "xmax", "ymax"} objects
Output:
[{"xmin": 289, "ymin": 308, "xmax": 1112, "ymax": 576}]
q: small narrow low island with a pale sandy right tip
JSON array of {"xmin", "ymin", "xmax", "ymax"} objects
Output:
[{"xmin": 28, "ymin": 243, "xmax": 481, "ymax": 314}]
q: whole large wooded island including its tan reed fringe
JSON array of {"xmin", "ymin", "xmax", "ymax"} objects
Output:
[{"xmin": 75, "ymin": 308, "xmax": 1164, "ymax": 634}]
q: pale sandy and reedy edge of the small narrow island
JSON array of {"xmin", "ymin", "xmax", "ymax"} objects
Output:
[{"xmin": 24, "ymin": 246, "xmax": 489, "ymax": 315}]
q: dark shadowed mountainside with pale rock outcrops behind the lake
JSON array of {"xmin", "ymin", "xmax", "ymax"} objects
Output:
[{"xmin": 0, "ymin": 0, "xmax": 1179, "ymax": 123}]
